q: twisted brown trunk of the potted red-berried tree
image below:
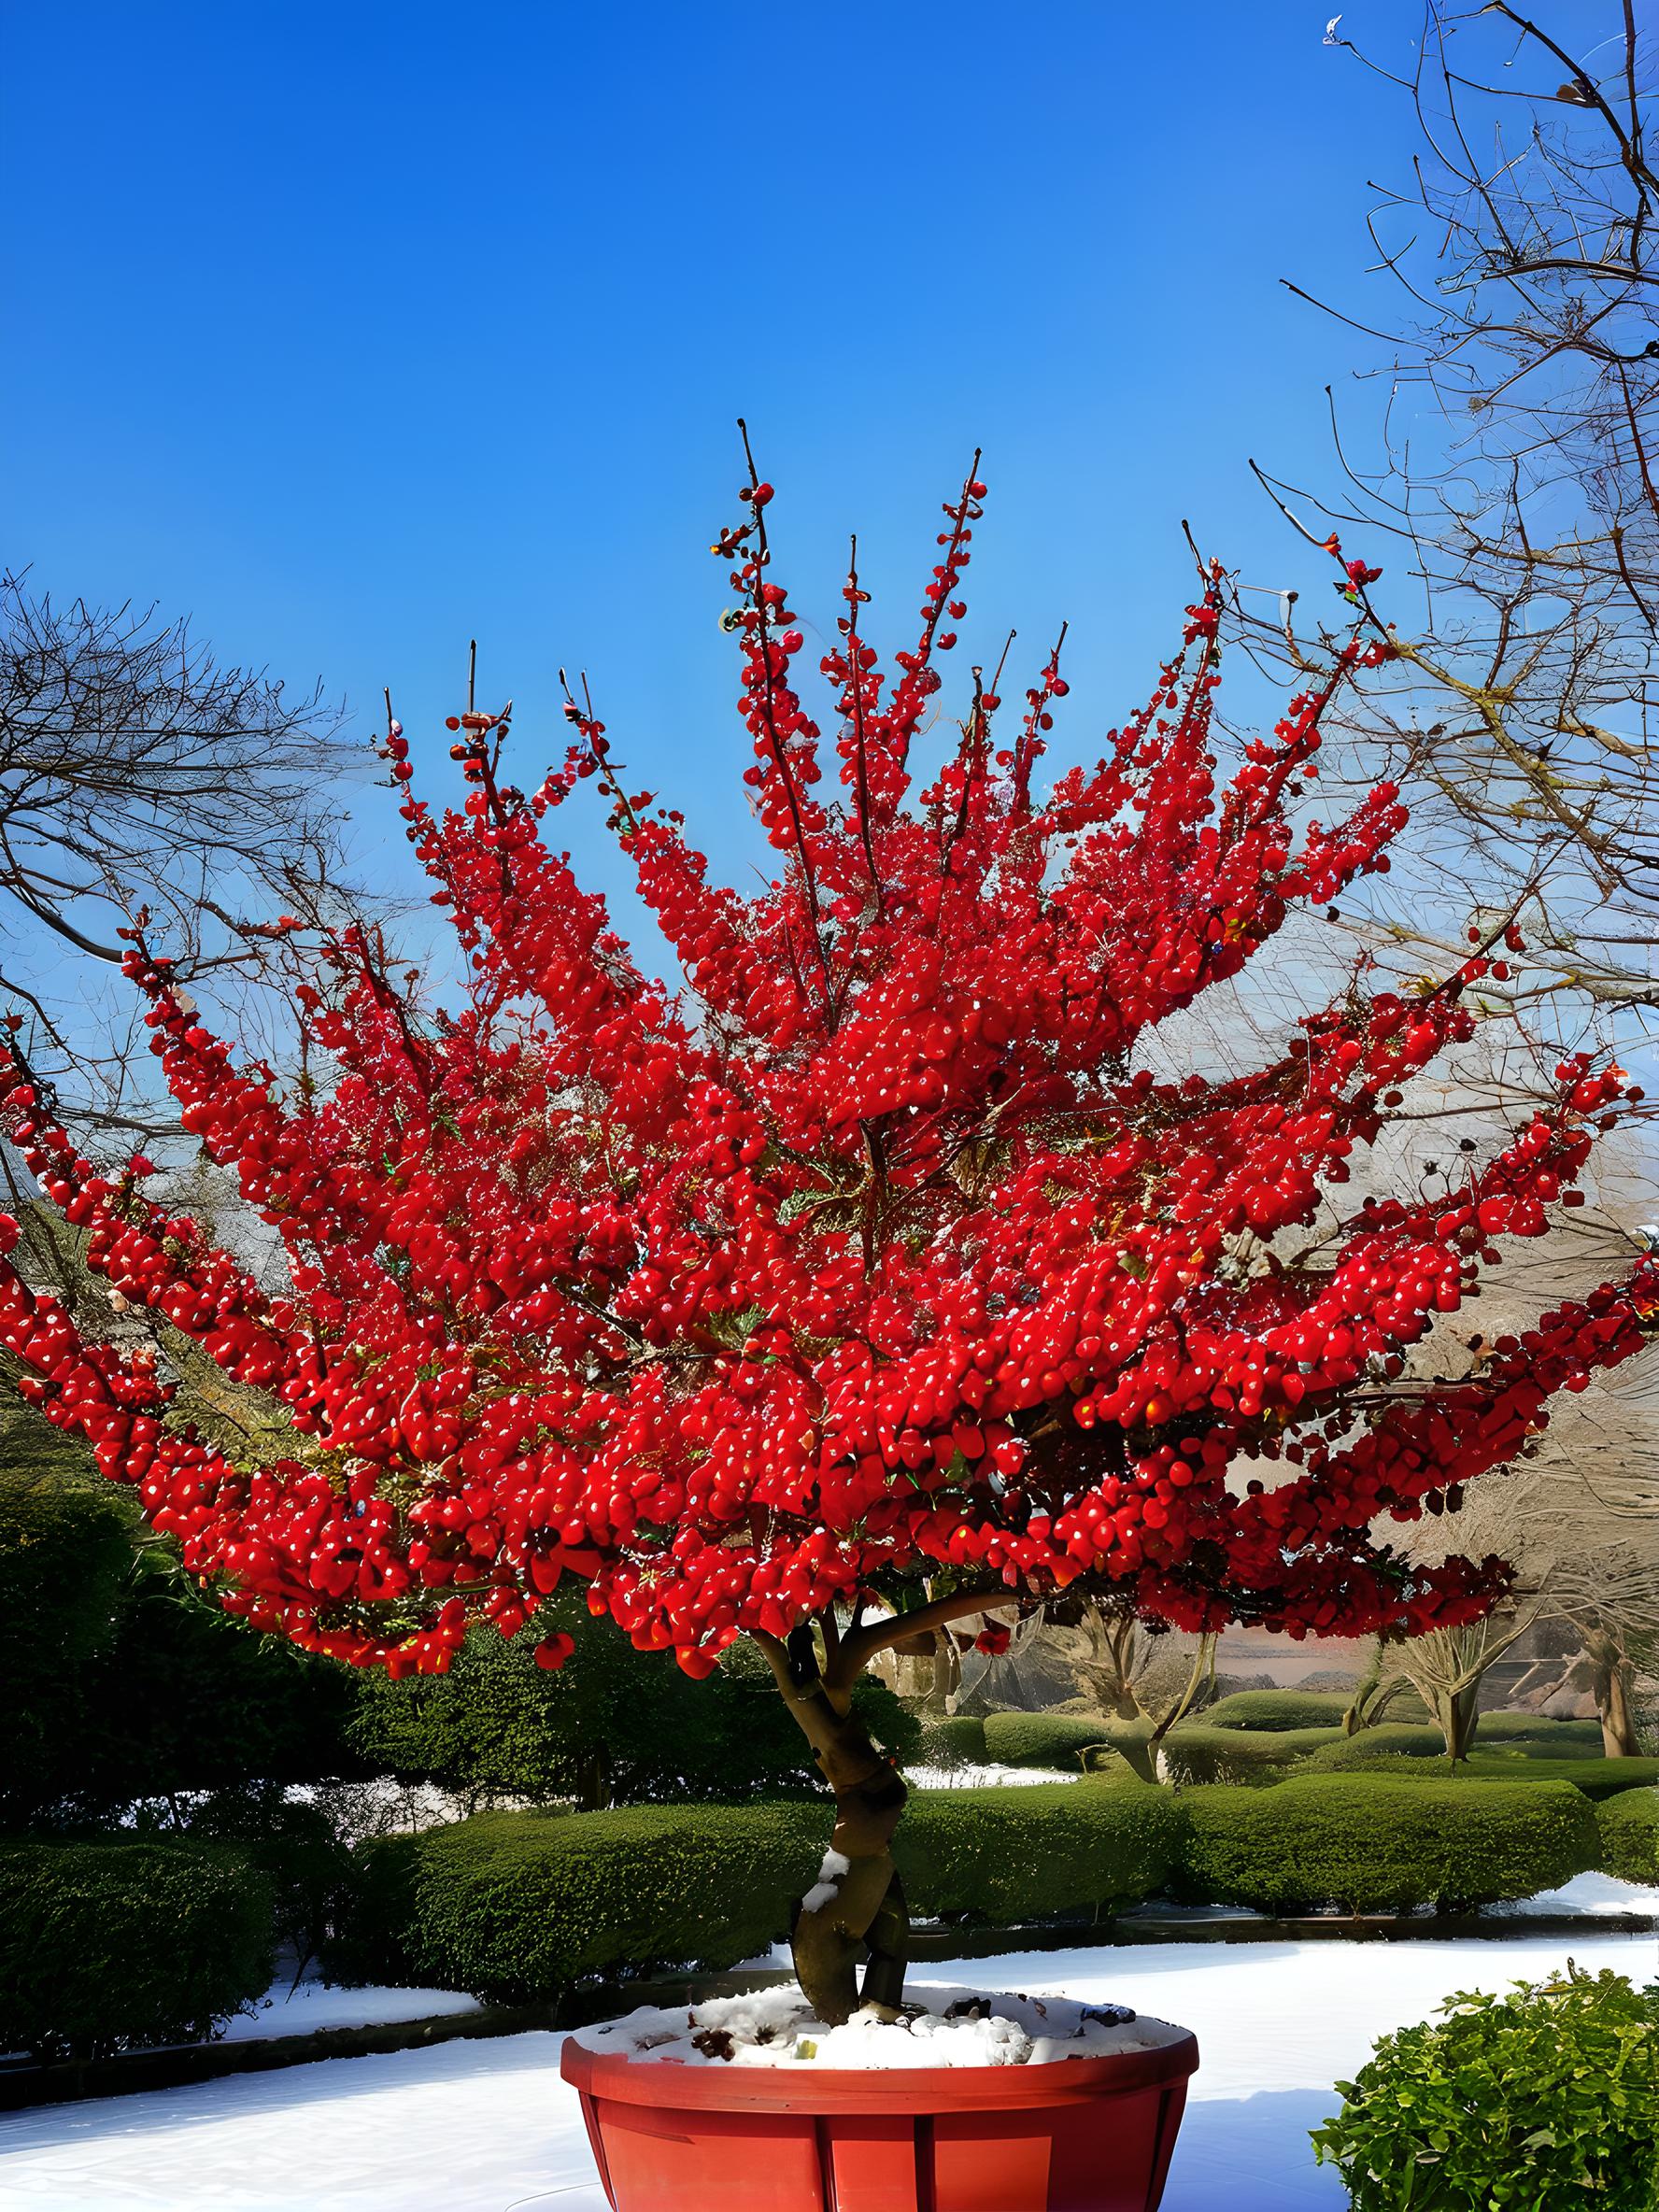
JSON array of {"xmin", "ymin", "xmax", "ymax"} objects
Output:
[{"xmin": 779, "ymin": 1635, "xmax": 909, "ymax": 2026}]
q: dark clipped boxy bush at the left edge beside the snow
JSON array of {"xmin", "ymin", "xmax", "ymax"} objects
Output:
[{"xmin": 0, "ymin": 1840, "xmax": 272, "ymax": 2057}]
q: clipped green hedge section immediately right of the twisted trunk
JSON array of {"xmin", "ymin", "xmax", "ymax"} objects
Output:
[{"xmin": 894, "ymin": 1780, "xmax": 1185, "ymax": 1927}]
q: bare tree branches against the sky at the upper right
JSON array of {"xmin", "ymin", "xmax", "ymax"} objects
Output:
[{"xmin": 1237, "ymin": 0, "xmax": 1659, "ymax": 1028}]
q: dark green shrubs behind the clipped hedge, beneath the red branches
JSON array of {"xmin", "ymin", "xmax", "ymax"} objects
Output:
[{"xmin": 349, "ymin": 1591, "xmax": 920, "ymax": 1809}]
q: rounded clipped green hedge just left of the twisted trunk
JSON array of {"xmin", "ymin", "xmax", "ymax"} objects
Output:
[{"xmin": 327, "ymin": 1798, "xmax": 831, "ymax": 2004}]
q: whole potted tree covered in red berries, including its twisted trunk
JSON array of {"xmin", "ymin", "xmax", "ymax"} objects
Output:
[{"xmin": 0, "ymin": 461, "xmax": 1657, "ymax": 2020}]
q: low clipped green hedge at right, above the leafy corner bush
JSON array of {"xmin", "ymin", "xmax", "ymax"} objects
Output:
[{"xmin": 1182, "ymin": 1774, "xmax": 1599, "ymax": 1913}]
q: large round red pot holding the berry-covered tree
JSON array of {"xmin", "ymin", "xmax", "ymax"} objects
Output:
[{"xmin": 561, "ymin": 2035, "xmax": 1198, "ymax": 2212}]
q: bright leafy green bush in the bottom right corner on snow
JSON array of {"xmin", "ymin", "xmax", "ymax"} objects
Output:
[{"xmin": 1314, "ymin": 1966, "xmax": 1659, "ymax": 2212}]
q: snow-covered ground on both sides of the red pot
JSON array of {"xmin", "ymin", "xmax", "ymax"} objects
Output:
[{"xmin": 0, "ymin": 1876, "xmax": 1659, "ymax": 2212}]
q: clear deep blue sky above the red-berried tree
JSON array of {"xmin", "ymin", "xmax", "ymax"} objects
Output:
[{"xmin": 0, "ymin": 0, "xmax": 1416, "ymax": 915}]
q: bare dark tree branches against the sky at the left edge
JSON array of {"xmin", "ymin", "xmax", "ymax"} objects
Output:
[{"xmin": 0, "ymin": 575, "xmax": 364, "ymax": 1126}]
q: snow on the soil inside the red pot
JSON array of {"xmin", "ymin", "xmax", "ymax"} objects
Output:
[{"xmin": 575, "ymin": 1982, "xmax": 1184, "ymax": 2073}]
